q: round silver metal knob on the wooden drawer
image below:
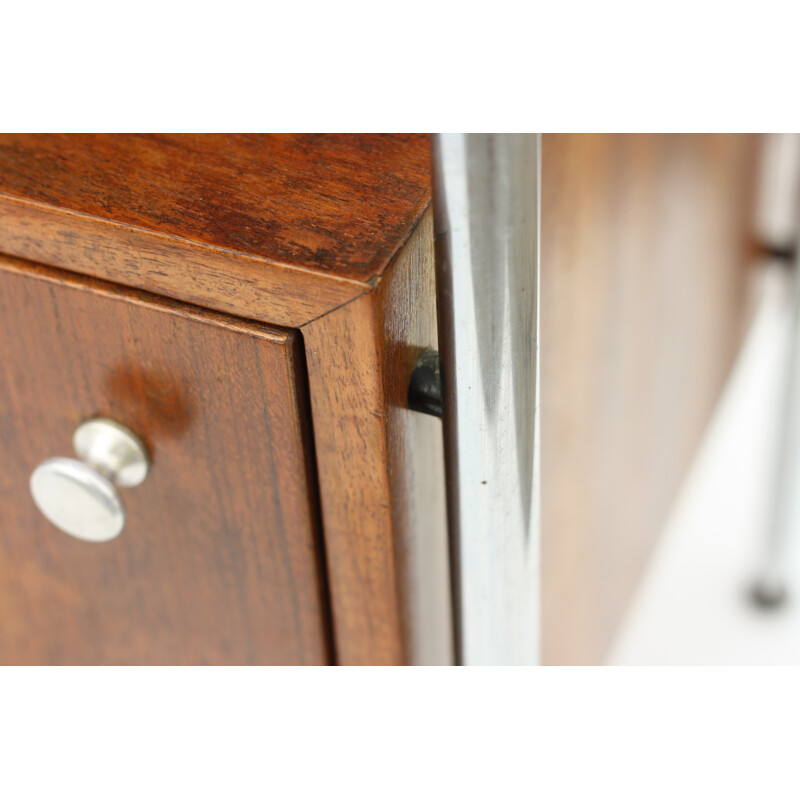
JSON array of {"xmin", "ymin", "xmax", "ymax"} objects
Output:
[{"xmin": 30, "ymin": 418, "xmax": 150, "ymax": 542}]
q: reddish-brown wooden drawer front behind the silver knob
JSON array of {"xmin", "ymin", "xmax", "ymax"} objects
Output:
[{"xmin": 0, "ymin": 258, "xmax": 331, "ymax": 664}]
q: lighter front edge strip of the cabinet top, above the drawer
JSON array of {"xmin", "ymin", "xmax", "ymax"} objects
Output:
[{"xmin": 0, "ymin": 195, "xmax": 370, "ymax": 327}]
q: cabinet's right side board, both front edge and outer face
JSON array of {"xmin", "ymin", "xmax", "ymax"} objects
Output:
[{"xmin": 302, "ymin": 206, "xmax": 453, "ymax": 664}]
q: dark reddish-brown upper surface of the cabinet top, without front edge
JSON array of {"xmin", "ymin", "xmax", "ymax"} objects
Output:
[{"xmin": 0, "ymin": 134, "xmax": 430, "ymax": 281}]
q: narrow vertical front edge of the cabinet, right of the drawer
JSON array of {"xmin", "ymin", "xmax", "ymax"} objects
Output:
[{"xmin": 303, "ymin": 292, "xmax": 408, "ymax": 665}]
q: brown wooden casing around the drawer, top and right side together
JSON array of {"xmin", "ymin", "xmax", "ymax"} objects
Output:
[{"xmin": 0, "ymin": 135, "xmax": 438, "ymax": 663}]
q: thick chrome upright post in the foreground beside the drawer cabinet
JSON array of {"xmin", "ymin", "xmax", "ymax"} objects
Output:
[{"xmin": 433, "ymin": 134, "xmax": 540, "ymax": 665}]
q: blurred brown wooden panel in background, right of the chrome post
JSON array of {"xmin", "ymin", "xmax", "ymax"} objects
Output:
[{"xmin": 540, "ymin": 134, "xmax": 757, "ymax": 664}]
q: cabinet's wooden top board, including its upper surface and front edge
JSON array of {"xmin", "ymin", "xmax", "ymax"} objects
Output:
[{"xmin": 0, "ymin": 134, "xmax": 430, "ymax": 327}]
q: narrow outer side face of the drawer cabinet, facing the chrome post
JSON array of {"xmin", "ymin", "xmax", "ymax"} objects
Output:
[{"xmin": 377, "ymin": 209, "xmax": 455, "ymax": 664}]
